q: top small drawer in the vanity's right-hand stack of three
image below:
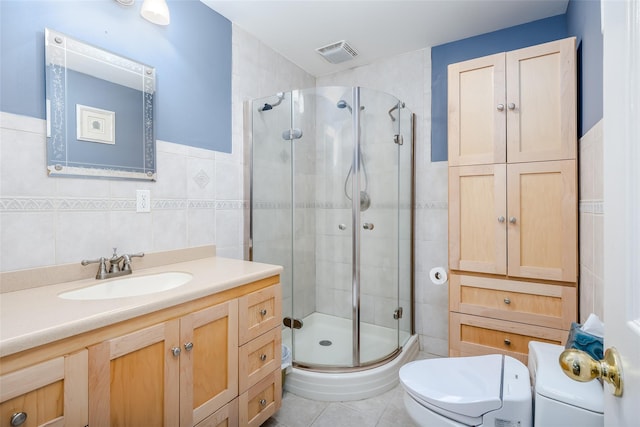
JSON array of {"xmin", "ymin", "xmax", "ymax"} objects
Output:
[{"xmin": 238, "ymin": 284, "xmax": 282, "ymax": 345}]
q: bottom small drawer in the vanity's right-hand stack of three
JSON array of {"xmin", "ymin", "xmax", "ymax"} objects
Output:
[{"xmin": 240, "ymin": 369, "xmax": 282, "ymax": 427}]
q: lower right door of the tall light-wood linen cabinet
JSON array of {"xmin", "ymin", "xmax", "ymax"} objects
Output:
[{"xmin": 507, "ymin": 160, "xmax": 578, "ymax": 283}]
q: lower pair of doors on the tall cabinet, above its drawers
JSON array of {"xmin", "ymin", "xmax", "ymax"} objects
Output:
[{"xmin": 449, "ymin": 160, "xmax": 578, "ymax": 283}]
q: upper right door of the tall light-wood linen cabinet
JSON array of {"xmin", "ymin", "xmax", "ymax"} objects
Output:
[{"xmin": 506, "ymin": 37, "xmax": 577, "ymax": 163}]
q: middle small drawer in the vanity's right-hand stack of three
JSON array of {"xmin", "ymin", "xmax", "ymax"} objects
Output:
[{"xmin": 238, "ymin": 327, "xmax": 282, "ymax": 393}]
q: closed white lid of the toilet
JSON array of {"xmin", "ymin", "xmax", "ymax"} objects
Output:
[{"xmin": 400, "ymin": 354, "xmax": 502, "ymax": 417}]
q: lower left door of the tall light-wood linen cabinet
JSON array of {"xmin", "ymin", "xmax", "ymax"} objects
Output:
[{"xmin": 449, "ymin": 164, "xmax": 507, "ymax": 274}]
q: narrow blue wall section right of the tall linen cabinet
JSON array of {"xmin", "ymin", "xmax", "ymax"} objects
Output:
[{"xmin": 567, "ymin": 0, "xmax": 603, "ymax": 136}]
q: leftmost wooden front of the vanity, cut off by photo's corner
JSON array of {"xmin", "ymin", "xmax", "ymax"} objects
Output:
[{"xmin": 0, "ymin": 350, "xmax": 88, "ymax": 427}]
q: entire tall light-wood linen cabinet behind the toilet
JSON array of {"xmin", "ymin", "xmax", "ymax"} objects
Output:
[{"xmin": 448, "ymin": 38, "xmax": 578, "ymax": 363}]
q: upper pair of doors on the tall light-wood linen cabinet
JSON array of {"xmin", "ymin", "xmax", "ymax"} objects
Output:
[{"xmin": 448, "ymin": 37, "xmax": 577, "ymax": 166}]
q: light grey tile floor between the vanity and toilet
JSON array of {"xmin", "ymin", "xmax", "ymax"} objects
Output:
[{"xmin": 262, "ymin": 384, "xmax": 416, "ymax": 427}]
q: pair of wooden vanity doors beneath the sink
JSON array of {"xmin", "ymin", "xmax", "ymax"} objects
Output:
[{"xmin": 89, "ymin": 300, "xmax": 238, "ymax": 427}]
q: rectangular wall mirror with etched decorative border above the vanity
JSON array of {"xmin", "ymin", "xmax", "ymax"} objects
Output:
[{"xmin": 45, "ymin": 29, "xmax": 156, "ymax": 181}]
